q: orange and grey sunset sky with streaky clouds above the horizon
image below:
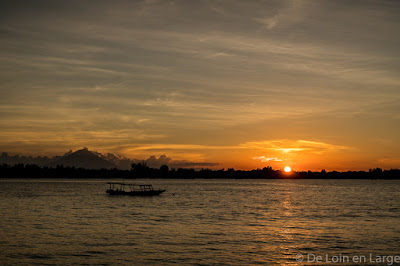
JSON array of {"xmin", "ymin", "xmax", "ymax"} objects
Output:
[{"xmin": 0, "ymin": 0, "xmax": 400, "ymax": 170}]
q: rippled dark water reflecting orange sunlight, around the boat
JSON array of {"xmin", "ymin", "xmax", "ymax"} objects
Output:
[{"xmin": 0, "ymin": 180, "xmax": 400, "ymax": 265}]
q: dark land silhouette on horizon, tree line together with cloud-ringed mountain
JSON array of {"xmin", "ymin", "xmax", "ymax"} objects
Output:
[{"xmin": 0, "ymin": 148, "xmax": 400, "ymax": 179}]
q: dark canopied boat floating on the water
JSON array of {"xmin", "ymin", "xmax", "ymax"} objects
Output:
[{"xmin": 106, "ymin": 182, "xmax": 165, "ymax": 196}]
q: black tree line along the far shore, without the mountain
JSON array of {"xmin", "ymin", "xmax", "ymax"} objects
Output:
[{"xmin": 0, "ymin": 162, "xmax": 400, "ymax": 179}]
